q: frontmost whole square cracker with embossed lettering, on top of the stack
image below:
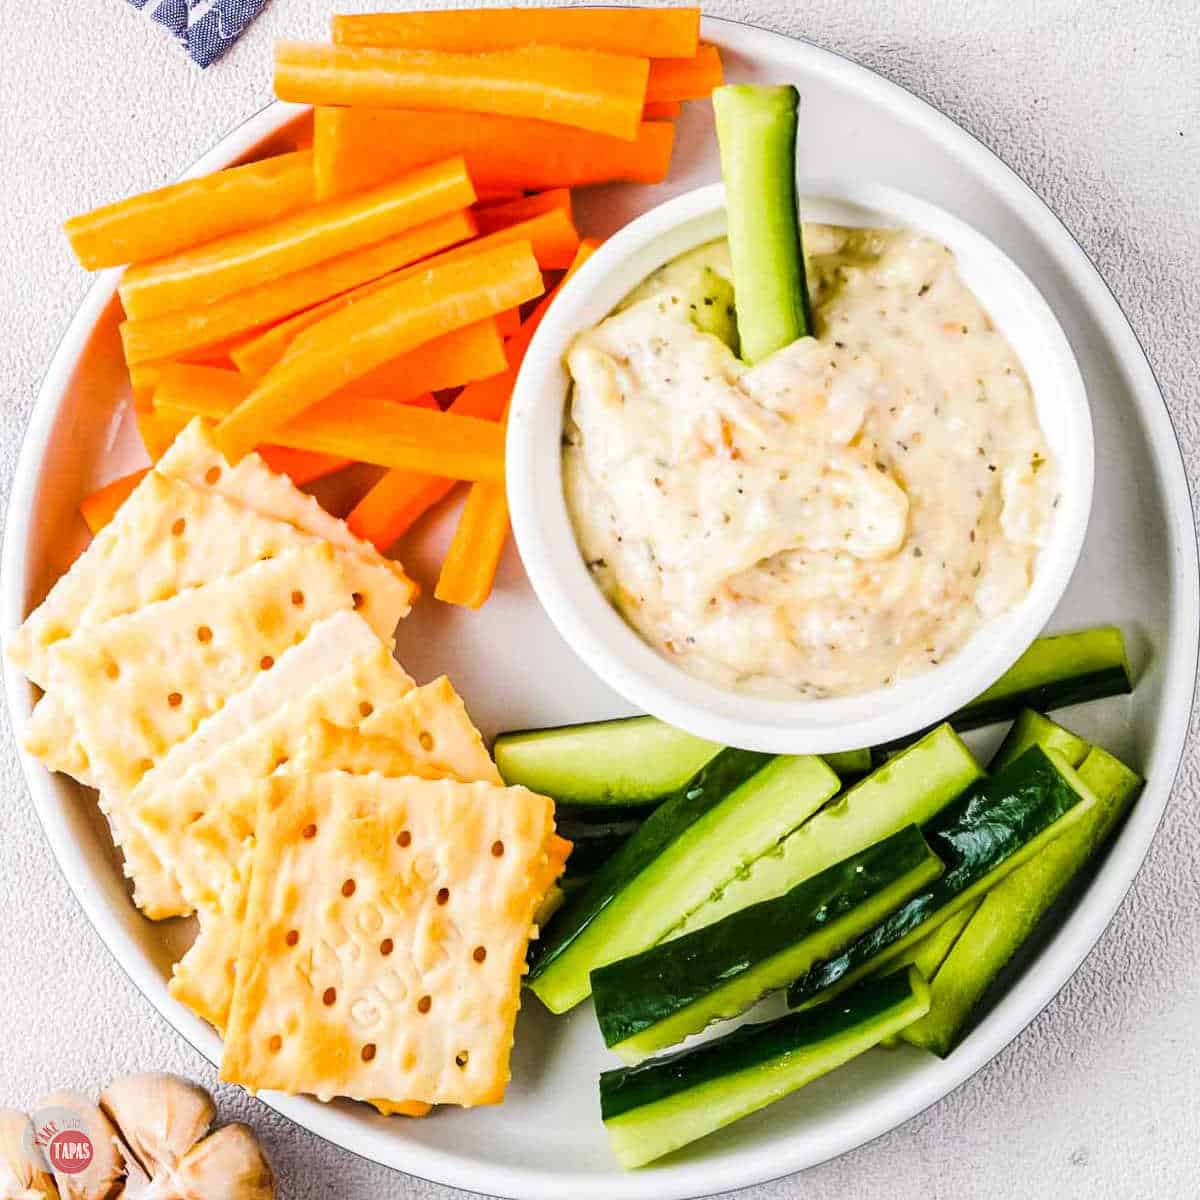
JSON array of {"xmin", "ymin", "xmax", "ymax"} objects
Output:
[{"xmin": 221, "ymin": 769, "xmax": 566, "ymax": 1105}]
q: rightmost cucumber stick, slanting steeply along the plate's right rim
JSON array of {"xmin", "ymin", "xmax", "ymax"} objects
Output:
[{"xmin": 901, "ymin": 749, "xmax": 1142, "ymax": 1057}]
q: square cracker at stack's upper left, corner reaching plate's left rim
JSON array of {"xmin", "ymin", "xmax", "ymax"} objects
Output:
[{"xmin": 8, "ymin": 468, "xmax": 414, "ymax": 688}]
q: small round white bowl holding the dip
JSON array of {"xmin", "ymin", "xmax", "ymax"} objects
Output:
[{"xmin": 508, "ymin": 181, "xmax": 1093, "ymax": 754}]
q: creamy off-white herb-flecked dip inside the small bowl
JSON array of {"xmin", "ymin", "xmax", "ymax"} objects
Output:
[{"xmin": 563, "ymin": 226, "xmax": 1057, "ymax": 698}]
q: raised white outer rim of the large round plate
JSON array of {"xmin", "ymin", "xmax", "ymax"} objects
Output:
[{"xmin": 0, "ymin": 17, "xmax": 1200, "ymax": 1200}]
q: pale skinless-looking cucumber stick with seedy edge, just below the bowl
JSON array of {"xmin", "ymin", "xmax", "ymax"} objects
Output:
[{"xmin": 671, "ymin": 725, "xmax": 983, "ymax": 936}]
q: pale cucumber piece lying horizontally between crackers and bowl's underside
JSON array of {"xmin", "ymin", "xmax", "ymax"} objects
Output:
[{"xmin": 492, "ymin": 716, "xmax": 721, "ymax": 809}]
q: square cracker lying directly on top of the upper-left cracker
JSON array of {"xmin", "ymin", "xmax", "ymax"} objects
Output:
[{"xmin": 37, "ymin": 542, "xmax": 354, "ymax": 911}]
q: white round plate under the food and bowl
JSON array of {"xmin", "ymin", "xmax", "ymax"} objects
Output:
[{"xmin": 0, "ymin": 20, "xmax": 1200, "ymax": 1200}]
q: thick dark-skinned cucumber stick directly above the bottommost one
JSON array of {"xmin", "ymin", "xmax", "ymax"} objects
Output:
[{"xmin": 592, "ymin": 826, "xmax": 942, "ymax": 1062}]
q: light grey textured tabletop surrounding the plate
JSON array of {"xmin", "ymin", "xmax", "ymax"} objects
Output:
[{"xmin": 0, "ymin": 0, "xmax": 1200, "ymax": 1200}]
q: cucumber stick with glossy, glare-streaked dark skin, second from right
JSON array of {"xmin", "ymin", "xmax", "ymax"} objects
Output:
[{"xmin": 787, "ymin": 746, "xmax": 1091, "ymax": 1008}]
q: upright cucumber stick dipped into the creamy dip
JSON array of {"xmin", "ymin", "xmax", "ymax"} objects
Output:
[{"xmin": 713, "ymin": 84, "xmax": 812, "ymax": 362}]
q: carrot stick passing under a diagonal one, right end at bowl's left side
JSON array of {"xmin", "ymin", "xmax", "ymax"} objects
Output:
[{"xmin": 155, "ymin": 364, "xmax": 504, "ymax": 482}]
